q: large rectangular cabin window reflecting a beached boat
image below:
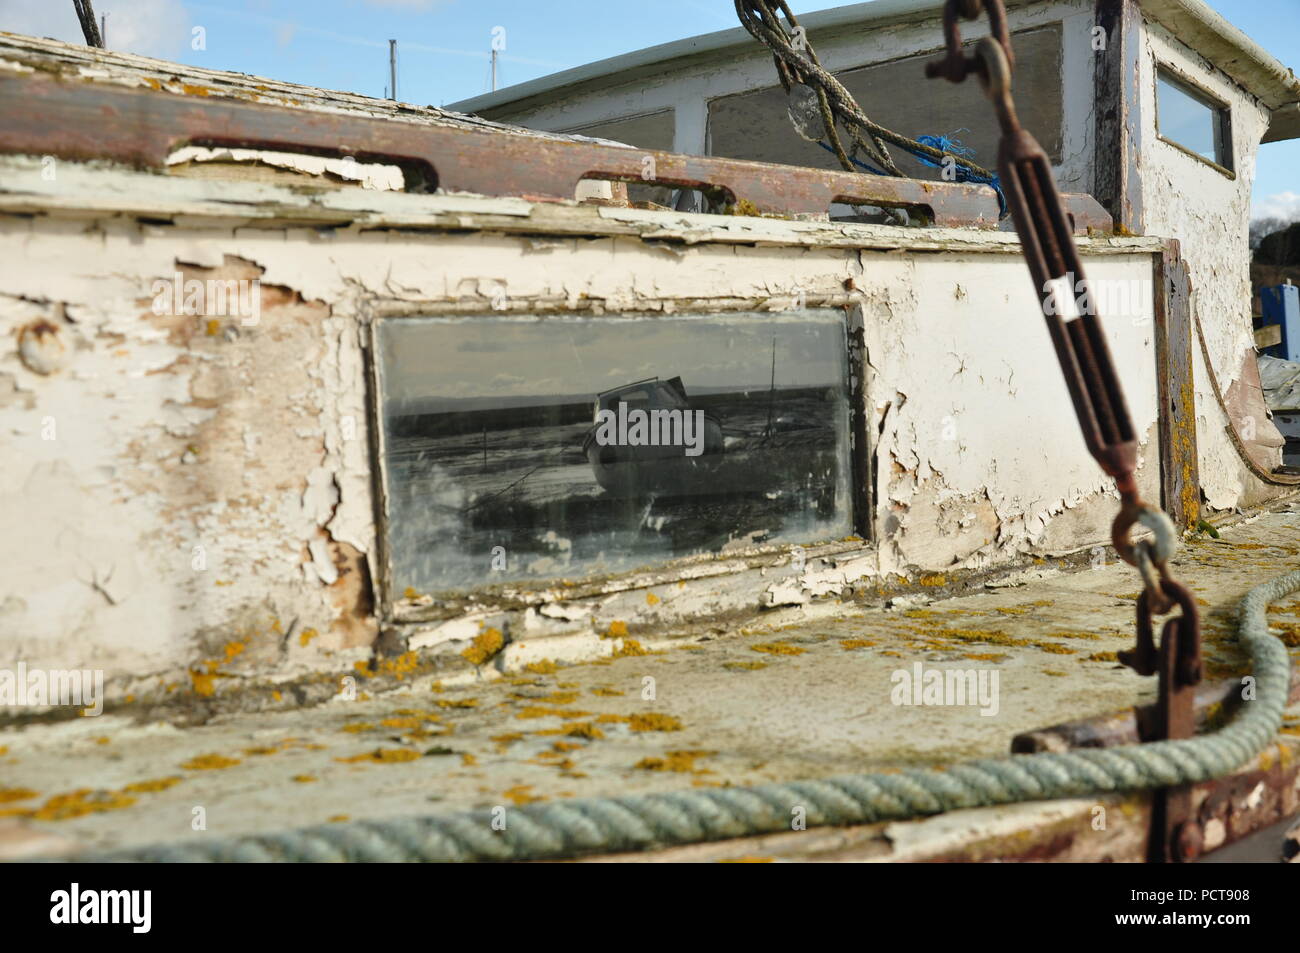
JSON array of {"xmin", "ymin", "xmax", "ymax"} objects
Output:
[{"xmin": 376, "ymin": 309, "xmax": 861, "ymax": 602}]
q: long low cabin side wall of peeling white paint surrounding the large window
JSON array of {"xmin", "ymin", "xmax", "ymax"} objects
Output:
[{"xmin": 0, "ymin": 152, "xmax": 1158, "ymax": 690}]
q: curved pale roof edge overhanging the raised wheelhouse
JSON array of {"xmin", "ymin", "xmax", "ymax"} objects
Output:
[{"xmin": 451, "ymin": 0, "xmax": 1300, "ymax": 142}]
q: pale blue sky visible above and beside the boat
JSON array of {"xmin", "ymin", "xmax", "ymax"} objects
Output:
[{"xmin": 0, "ymin": 0, "xmax": 1300, "ymax": 220}]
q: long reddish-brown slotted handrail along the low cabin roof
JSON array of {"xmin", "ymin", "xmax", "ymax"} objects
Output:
[{"xmin": 0, "ymin": 73, "xmax": 1112, "ymax": 233}]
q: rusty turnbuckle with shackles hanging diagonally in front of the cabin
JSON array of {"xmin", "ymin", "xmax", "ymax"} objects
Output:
[{"xmin": 926, "ymin": 0, "xmax": 1201, "ymax": 861}]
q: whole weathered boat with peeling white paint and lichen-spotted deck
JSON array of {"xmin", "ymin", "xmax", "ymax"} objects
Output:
[{"xmin": 0, "ymin": 0, "xmax": 1300, "ymax": 861}]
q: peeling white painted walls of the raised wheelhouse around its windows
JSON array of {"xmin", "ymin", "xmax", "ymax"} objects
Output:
[{"xmin": 465, "ymin": 0, "xmax": 1282, "ymax": 510}]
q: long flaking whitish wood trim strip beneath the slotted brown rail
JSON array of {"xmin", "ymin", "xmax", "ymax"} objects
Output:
[{"xmin": 0, "ymin": 156, "xmax": 1161, "ymax": 255}]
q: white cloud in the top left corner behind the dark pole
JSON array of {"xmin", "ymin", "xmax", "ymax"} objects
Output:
[{"xmin": 0, "ymin": 0, "xmax": 190, "ymax": 60}]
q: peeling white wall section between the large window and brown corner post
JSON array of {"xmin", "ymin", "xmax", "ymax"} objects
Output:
[{"xmin": 862, "ymin": 255, "xmax": 1160, "ymax": 571}]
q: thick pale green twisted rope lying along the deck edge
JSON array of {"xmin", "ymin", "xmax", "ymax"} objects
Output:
[{"xmin": 55, "ymin": 572, "xmax": 1300, "ymax": 862}]
